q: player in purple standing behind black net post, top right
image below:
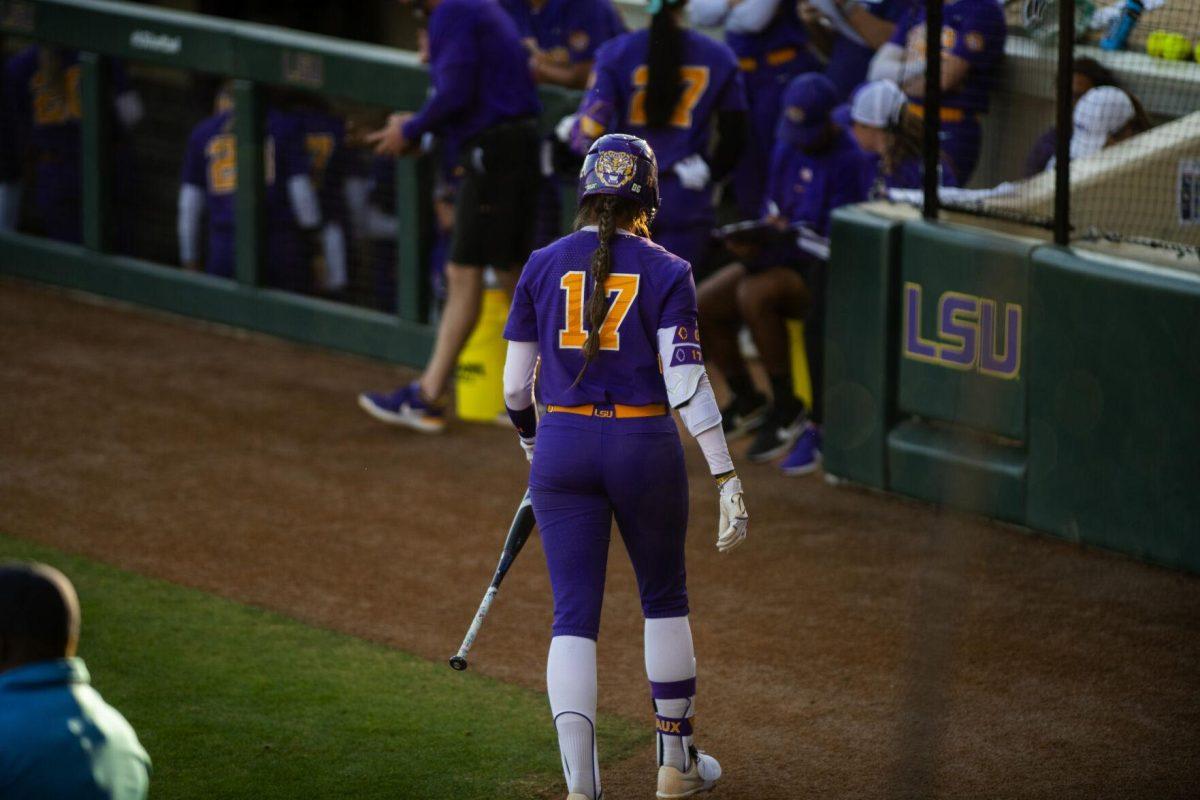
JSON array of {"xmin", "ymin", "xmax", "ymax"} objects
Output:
[{"xmin": 869, "ymin": 0, "xmax": 1008, "ymax": 185}]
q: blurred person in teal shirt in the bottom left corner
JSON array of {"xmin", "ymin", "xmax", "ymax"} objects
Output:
[{"xmin": 0, "ymin": 563, "xmax": 150, "ymax": 800}]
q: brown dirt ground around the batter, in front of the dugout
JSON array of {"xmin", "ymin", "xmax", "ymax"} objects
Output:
[{"xmin": 7, "ymin": 281, "xmax": 1200, "ymax": 800}]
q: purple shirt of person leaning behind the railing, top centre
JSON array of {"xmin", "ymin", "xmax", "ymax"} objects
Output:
[{"xmin": 500, "ymin": 0, "xmax": 625, "ymax": 64}]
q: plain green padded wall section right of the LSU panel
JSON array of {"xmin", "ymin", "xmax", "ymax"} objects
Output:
[{"xmin": 1028, "ymin": 247, "xmax": 1200, "ymax": 571}]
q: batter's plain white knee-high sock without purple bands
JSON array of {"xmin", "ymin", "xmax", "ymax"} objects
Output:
[{"xmin": 546, "ymin": 636, "xmax": 600, "ymax": 800}]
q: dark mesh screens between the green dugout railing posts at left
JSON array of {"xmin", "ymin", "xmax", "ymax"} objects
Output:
[{"xmin": 0, "ymin": 38, "xmax": 439, "ymax": 311}]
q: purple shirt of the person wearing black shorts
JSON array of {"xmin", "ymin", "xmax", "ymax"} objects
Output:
[{"xmin": 404, "ymin": 0, "xmax": 541, "ymax": 157}]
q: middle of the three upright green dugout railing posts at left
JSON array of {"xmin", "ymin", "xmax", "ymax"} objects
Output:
[{"xmin": 233, "ymin": 80, "xmax": 264, "ymax": 287}]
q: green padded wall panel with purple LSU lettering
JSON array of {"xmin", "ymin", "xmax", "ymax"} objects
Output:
[{"xmin": 895, "ymin": 221, "xmax": 1032, "ymax": 440}]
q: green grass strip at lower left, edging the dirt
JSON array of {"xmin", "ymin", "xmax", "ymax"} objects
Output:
[{"xmin": 0, "ymin": 536, "xmax": 642, "ymax": 800}]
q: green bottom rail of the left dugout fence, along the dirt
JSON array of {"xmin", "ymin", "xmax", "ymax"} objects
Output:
[{"xmin": 0, "ymin": 234, "xmax": 433, "ymax": 366}]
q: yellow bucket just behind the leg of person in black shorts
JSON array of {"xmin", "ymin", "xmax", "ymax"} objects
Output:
[{"xmin": 455, "ymin": 289, "xmax": 509, "ymax": 422}]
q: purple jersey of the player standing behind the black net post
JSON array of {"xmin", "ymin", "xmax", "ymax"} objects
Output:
[{"xmin": 889, "ymin": 0, "xmax": 1008, "ymax": 113}]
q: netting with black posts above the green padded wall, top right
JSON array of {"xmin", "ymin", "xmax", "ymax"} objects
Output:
[{"xmin": 892, "ymin": 0, "xmax": 1200, "ymax": 266}]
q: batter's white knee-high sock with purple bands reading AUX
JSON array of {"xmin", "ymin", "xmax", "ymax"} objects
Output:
[{"xmin": 646, "ymin": 616, "xmax": 696, "ymax": 771}]
